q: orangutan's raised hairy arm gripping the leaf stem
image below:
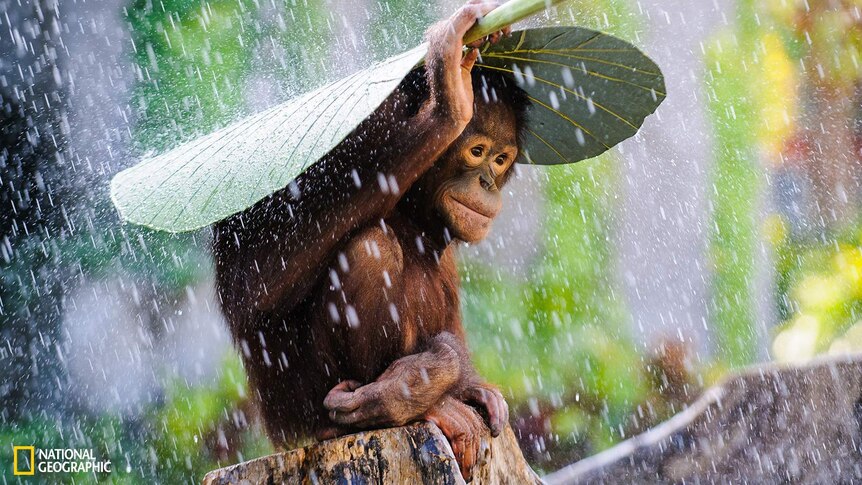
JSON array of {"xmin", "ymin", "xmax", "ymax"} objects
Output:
[{"xmin": 216, "ymin": 3, "xmax": 506, "ymax": 318}]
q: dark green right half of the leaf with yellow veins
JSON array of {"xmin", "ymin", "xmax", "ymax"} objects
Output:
[{"xmin": 477, "ymin": 27, "xmax": 665, "ymax": 165}]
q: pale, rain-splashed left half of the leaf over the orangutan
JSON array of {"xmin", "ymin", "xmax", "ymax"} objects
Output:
[{"xmin": 111, "ymin": 44, "xmax": 427, "ymax": 232}]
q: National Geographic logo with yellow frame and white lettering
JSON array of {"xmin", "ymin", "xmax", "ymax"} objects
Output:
[{"xmin": 12, "ymin": 445, "xmax": 111, "ymax": 475}]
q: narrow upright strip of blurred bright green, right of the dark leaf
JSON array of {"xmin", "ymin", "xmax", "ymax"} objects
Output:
[{"xmin": 706, "ymin": 28, "xmax": 760, "ymax": 366}]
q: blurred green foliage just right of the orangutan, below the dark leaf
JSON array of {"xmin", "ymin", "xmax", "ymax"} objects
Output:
[{"xmin": 463, "ymin": 157, "xmax": 648, "ymax": 464}]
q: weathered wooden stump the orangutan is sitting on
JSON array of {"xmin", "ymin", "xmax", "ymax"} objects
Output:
[{"xmin": 203, "ymin": 423, "xmax": 539, "ymax": 485}]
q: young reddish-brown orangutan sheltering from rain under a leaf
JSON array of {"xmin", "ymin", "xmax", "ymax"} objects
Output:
[{"xmin": 214, "ymin": 1, "xmax": 529, "ymax": 477}]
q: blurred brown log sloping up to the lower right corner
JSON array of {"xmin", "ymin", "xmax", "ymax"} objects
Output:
[{"xmin": 543, "ymin": 355, "xmax": 862, "ymax": 485}]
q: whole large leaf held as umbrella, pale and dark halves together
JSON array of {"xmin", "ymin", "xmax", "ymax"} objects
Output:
[{"xmin": 111, "ymin": 27, "xmax": 665, "ymax": 232}]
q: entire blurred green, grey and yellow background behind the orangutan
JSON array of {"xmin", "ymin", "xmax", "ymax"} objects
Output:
[{"xmin": 0, "ymin": 0, "xmax": 862, "ymax": 483}]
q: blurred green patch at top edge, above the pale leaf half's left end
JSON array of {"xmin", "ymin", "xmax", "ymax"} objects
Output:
[{"xmin": 128, "ymin": 0, "xmax": 249, "ymax": 144}]
